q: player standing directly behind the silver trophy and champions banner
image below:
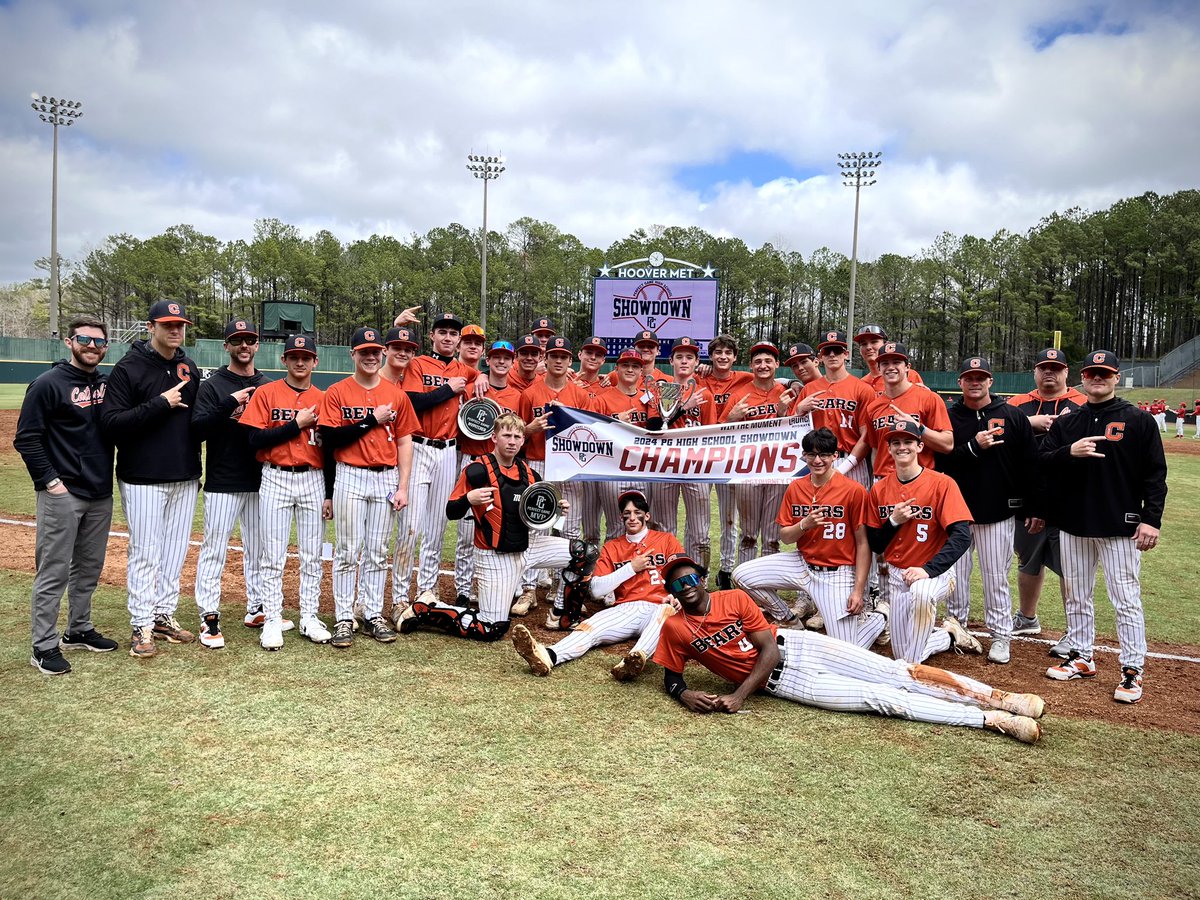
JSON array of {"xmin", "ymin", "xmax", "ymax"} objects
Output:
[{"xmin": 650, "ymin": 337, "xmax": 716, "ymax": 564}]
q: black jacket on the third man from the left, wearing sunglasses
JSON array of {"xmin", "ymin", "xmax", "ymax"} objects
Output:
[{"xmin": 192, "ymin": 366, "xmax": 270, "ymax": 493}]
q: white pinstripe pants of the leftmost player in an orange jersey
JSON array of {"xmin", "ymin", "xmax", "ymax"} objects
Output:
[{"xmin": 258, "ymin": 466, "xmax": 325, "ymax": 620}]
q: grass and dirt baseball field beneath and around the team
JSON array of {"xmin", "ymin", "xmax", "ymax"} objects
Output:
[{"xmin": 0, "ymin": 390, "xmax": 1200, "ymax": 899}]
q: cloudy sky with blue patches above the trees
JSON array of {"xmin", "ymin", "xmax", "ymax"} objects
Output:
[{"xmin": 0, "ymin": 0, "xmax": 1200, "ymax": 283}]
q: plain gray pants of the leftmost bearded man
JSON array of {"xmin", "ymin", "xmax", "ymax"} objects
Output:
[{"xmin": 32, "ymin": 491, "xmax": 113, "ymax": 653}]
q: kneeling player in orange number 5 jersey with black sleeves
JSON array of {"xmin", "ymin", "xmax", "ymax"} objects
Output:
[{"xmin": 866, "ymin": 420, "xmax": 983, "ymax": 662}]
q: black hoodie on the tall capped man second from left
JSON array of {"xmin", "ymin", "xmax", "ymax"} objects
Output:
[{"xmin": 100, "ymin": 341, "xmax": 200, "ymax": 485}]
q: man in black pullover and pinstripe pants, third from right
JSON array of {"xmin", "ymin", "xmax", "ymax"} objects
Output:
[{"xmin": 937, "ymin": 356, "xmax": 1044, "ymax": 665}]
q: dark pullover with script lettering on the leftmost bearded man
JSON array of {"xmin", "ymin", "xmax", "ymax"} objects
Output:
[{"xmin": 12, "ymin": 360, "xmax": 113, "ymax": 500}]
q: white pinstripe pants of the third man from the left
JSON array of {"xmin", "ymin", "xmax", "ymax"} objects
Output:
[{"xmin": 196, "ymin": 491, "xmax": 265, "ymax": 616}]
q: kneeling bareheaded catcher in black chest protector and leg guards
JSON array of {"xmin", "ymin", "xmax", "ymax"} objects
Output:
[{"xmin": 398, "ymin": 413, "xmax": 595, "ymax": 641}]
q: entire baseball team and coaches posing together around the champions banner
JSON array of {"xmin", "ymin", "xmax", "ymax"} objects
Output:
[{"xmin": 13, "ymin": 300, "xmax": 1166, "ymax": 743}]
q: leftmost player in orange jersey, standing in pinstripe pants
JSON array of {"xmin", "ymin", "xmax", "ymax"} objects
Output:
[{"xmin": 240, "ymin": 335, "xmax": 334, "ymax": 650}]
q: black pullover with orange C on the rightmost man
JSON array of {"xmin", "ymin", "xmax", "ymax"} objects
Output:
[{"xmin": 1040, "ymin": 397, "xmax": 1166, "ymax": 538}]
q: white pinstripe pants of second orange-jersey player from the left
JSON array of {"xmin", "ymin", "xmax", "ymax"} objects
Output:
[{"xmin": 334, "ymin": 462, "xmax": 393, "ymax": 622}]
